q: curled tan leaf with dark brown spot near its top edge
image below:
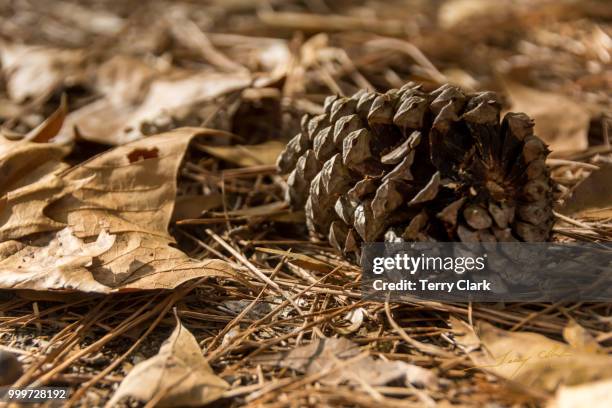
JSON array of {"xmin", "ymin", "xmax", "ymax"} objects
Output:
[{"xmin": 47, "ymin": 128, "xmax": 229, "ymax": 289}]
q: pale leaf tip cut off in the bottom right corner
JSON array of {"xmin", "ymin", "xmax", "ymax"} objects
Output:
[{"xmin": 547, "ymin": 380, "xmax": 612, "ymax": 408}]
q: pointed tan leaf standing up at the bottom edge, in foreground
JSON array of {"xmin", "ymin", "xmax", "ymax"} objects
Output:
[{"xmin": 106, "ymin": 319, "xmax": 229, "ymax": 407}]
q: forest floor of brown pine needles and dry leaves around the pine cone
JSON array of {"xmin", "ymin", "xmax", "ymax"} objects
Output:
[{"xmin": 0, "ymin": 0, "xmax": 612, "ymax": 408}]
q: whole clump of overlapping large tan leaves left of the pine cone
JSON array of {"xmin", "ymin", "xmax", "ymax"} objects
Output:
[{"xmin": 0, "ymin": 128, "xmax": 232, "ymax": 293}]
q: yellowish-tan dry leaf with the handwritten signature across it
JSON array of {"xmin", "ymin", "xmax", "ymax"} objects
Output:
[{"xmin": 457, "ymin": 322, "xmax": 612, "ymax": 392}]
